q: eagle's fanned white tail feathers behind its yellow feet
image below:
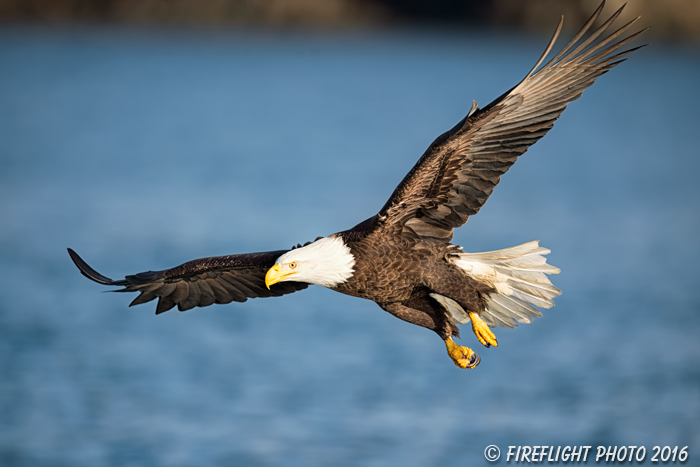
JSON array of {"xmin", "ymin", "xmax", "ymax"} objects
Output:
[{"xmin": 448, "ymin": 240, "xmax": 561, "ymax": 328}]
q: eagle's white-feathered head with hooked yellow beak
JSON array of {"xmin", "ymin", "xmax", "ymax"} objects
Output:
[{"xmin": 265, "ymin": 235, "xmax": 355, "ymax": 289}]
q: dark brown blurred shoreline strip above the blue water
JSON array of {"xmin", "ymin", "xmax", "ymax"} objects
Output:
[{"xmin": 0, "ymin": 0, "xmax": 700, "ymax": 42}]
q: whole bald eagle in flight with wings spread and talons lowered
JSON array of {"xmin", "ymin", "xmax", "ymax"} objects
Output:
[{"xmin": 68, "ymin": 2, "xmax": 644, "ymax": 368}]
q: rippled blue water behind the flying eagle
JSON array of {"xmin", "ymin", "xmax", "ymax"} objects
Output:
[{"xmin": 0, "ymin": 27, "xmax": 700, "ymax": 467}]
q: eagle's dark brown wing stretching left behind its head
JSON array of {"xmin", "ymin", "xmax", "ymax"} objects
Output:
[{"xmin": 68, "ymin": 248, "xmax": 308, "ymax": 314}]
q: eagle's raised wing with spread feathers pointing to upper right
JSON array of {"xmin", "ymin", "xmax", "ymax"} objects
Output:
[{"xmin": 379, "ymin": 2, "xmax": 644, "ymax": 242}]
